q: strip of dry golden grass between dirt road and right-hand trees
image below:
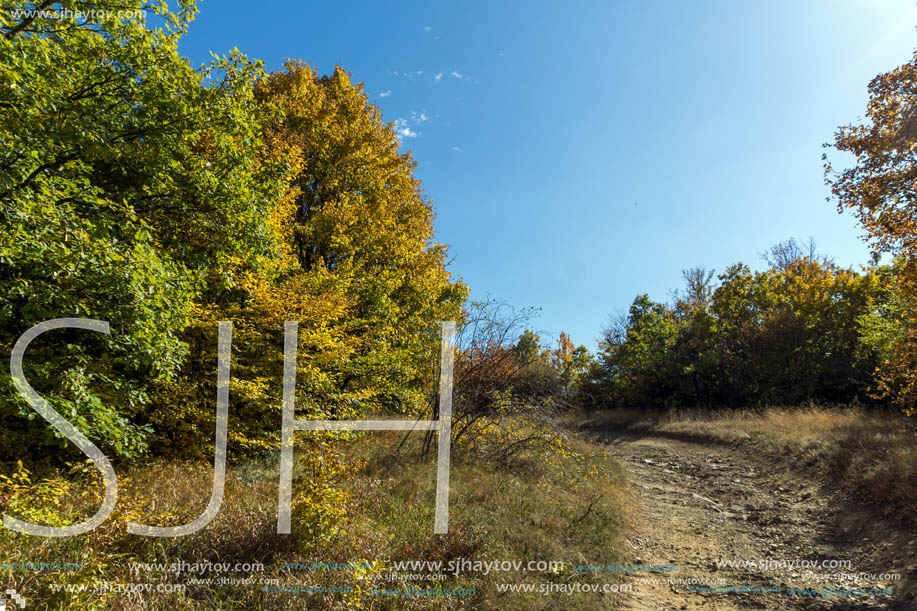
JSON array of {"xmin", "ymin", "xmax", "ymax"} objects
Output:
[{"xmin": 570, "ymin": 405, "xmax": 917, "ymax": 526}]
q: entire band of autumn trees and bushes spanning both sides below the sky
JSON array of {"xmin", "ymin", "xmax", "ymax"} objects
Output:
[{"xmin": 0, "ymin": 0, "xmax": 917, "ymax": 470}]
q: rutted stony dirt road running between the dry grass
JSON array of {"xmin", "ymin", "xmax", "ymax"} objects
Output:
[{"xmin": 601, "ymin": 433, "xmax": 917, "ymax": 611}]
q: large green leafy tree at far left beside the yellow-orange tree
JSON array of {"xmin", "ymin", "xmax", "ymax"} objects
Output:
[{"xmin": 0, "ymin": 0, "xmax": 285, "ymax": 455}]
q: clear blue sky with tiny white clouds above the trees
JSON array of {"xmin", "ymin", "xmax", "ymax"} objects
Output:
[{"xmin": 182, "ymin": 0, "xmax": 917, "ymax": 349}]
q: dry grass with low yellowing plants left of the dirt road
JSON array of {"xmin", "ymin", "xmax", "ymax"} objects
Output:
[{"xmin": 0, "ymin": 426, "xmax": 625, "ymax": 611}]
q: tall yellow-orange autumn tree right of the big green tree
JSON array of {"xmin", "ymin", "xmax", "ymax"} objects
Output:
[{"xmin": 147, "ymin": 62, "xmax": 467, "ymax": 452}]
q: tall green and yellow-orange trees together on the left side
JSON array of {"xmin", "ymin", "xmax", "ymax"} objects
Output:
[{"xmin": 0, "ymin": 0, "xmax": 467, "ymax": 460}]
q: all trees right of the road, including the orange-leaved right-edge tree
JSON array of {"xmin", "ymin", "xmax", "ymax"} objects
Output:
[{"xmin": 580, "ymin": 44, "xmax": 917, "ymax": 416}]
